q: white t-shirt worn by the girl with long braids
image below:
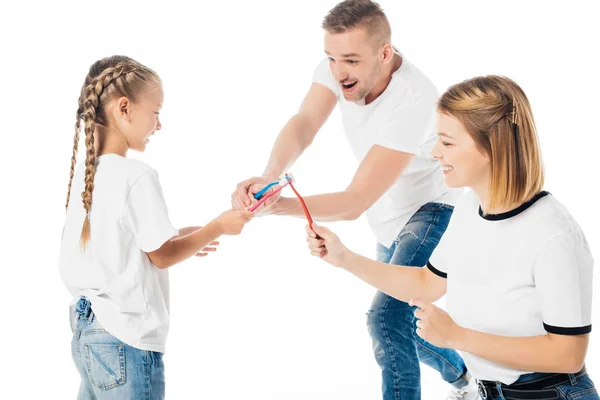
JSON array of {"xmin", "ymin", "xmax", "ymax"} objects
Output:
[{"xmin": 59, "ymin": 154, "xmax": 178, "ymax": 353}]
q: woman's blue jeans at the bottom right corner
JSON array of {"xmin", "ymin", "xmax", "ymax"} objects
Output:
[{"xmin": 488, "ymin": 373, "xmax": 600, "ymax": 400}]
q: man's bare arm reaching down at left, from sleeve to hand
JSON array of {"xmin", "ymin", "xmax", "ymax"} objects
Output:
[{"xmin": 231, "ymin": 83, "xmax": 337, "ymax": 208}]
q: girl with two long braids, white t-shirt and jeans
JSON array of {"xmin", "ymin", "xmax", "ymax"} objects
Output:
[{"xmin": 59, "ymin": 56, "xmax": 253, "ymax": 399}]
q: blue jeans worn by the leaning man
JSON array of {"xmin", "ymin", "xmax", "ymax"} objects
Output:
[{"xmin": 367, "ymin": 203, "xmax": 468, "ymax": 400}]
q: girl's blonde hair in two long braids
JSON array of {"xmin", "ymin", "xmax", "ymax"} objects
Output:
[{"xmin": 65, "ymin": 56, "xmax": 161, "ymax": 250}]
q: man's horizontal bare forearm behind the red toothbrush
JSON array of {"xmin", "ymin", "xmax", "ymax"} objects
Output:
[{"xmin": 271, "ymin": 191, "xmax": 366, "ymax": 222}]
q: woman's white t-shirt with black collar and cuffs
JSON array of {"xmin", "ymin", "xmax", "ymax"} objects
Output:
[{"xmin": 428, "ymin": 192, "xmax": 594, "ymax": 385}]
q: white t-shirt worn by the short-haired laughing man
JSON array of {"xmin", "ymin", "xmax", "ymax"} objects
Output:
[{"xmin": 313, "ymin": 53, "xmax": 458, "ymax": 247}]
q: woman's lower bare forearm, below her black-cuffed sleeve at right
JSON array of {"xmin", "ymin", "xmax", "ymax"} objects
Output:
[{"xmin": 452, "ymin": 328, "xmax": 587, "ymax": 373}]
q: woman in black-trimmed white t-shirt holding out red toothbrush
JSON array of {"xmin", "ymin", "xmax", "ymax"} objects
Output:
[{"xmin": 307, "ymin": 76, "xmax": 599, "ymax": 400}]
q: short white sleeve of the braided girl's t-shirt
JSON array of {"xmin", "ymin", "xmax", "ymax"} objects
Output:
[{"xmin": 123, "ymin": 170, "xmax": 178, "ymax": 253}]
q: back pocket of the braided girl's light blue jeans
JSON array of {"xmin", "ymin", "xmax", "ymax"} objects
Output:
[{"xmin": 84, "ymin": 343, "xmax": 126, "ymax": 390}]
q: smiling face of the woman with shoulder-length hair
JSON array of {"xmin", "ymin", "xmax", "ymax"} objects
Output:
[{"xmin": 431, "ymin": 112, "xmax": 489, "ymax": 189}]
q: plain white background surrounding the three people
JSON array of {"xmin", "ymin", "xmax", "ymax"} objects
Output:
[{"xmin": 0, "ymin": 0, "xmax": 600, "ymax": 400}]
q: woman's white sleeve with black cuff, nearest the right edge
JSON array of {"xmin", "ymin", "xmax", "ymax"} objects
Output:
[{"xmin": 534, "ymin": 233, "xmax": 593, "ymax": 335}]
